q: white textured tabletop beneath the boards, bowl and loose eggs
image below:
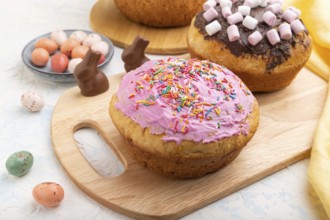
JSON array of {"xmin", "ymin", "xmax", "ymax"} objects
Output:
[{"xmin": 0, "ymin": 0, "xmax": 327, "ymax": 220}]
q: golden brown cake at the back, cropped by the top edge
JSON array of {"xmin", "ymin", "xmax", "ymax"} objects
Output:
[{"xmin": 114, "ymin": 0, "xmax": 204, "ymax": 27}]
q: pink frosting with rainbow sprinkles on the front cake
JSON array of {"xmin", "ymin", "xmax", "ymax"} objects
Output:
[{"xmin": 116, "ymin": 58, "xmax": 254, "ymax": 144}]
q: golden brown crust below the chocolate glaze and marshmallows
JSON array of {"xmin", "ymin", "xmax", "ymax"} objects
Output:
[{"xmin": 187, "ymin": 18, "xmax": 312, "ymax": 92}]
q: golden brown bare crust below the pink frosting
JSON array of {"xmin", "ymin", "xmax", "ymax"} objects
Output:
[{"xmin": 110, "ymin": 95, "xmax": 259, "ymax": 179}]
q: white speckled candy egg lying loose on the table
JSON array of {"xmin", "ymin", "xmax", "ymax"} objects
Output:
[{"xmin": 21, "ymin": 91, "xmax": 44, "ymax": 112}]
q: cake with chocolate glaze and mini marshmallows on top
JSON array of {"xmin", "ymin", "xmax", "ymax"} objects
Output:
[{"xmin": 187, "ymin": 0, "xmax": 312, "ymax": 92}]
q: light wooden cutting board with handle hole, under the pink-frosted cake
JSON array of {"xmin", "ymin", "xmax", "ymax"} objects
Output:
[{"xmin": 51, "ymin": 69, "xmax": 327, "ymax": 219}]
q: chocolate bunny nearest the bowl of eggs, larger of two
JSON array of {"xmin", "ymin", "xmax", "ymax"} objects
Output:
[{"xmin": 74, "ymin": 50, "xmax": 109, "ymax": 96}]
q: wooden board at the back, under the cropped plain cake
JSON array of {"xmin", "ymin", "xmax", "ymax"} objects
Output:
[{"xmin": 90, "ymin": 0, "xmax": 189, "ymax": 54}]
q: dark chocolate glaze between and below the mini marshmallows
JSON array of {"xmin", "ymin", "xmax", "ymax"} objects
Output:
[{"xmin": 194, "ymin": 0, "xmax": 310, "ymax": 72}]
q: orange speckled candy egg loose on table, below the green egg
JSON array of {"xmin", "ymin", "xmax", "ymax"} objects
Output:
[{"xmin": 32, "ymin": 182, "xmax": 64, "ymax": 208}]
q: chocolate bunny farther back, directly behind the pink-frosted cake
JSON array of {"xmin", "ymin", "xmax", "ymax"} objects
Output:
[{"xmin": 121, "ymin": 35, "xmax": 150, "ymax": 72}]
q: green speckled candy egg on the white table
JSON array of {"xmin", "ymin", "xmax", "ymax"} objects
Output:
[{"xmin": 6, "ymin": 151, "xmax": 33, "ymax": 177}]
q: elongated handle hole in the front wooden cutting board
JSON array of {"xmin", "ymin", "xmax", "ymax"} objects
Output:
[{"xmin": 74, "ymin": 127, "xmax": 125, "ymax": 177}]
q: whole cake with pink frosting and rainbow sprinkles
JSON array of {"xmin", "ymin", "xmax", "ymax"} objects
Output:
[{"xmin": 109, "ymin": 58, "xmax": 259, "ymax": 179}]
